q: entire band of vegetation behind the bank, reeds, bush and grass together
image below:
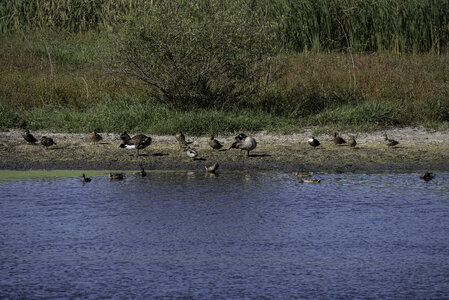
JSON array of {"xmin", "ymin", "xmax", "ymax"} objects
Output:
[{"xmin": 0, "ymin": 0, "xmax": 449, "ymax": 135}]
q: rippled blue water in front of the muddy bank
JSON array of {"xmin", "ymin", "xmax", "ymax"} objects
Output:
[{"xmin": 0, "ymin": 173, "xmax": 449, "ymax": 299}]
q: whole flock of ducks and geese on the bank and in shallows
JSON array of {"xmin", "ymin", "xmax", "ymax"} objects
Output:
[{"xmin": 22, "ymin": 130, "xmax": 435, "ymax": 183}]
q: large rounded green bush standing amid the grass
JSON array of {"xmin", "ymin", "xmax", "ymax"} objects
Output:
[{"xmin": 113, "ymin": 1, "xmax": 274, "ymax": 111}]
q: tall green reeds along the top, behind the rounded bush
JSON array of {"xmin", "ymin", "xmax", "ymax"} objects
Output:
[{"xmin": 0, "ymin": 0, "xmax": 449, "ymax": 53}]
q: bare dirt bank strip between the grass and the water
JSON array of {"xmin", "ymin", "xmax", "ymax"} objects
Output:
[{"xmin": 0, "ymin": 128, "xmax": 449, "ymax": 172}]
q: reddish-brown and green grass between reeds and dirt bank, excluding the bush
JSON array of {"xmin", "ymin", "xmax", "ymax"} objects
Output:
[{"xmin": 0, "ymin": 32, "xmax": 449, "ymax": 135}]
